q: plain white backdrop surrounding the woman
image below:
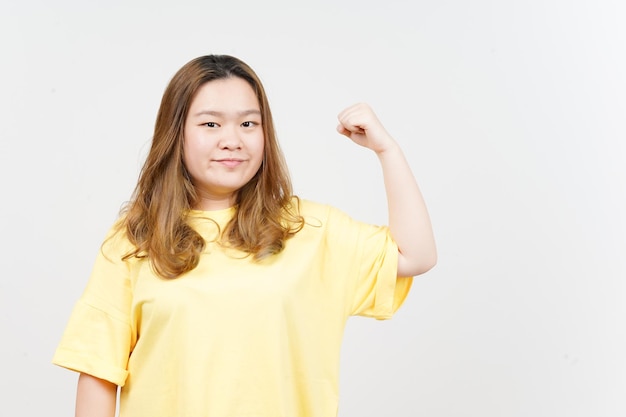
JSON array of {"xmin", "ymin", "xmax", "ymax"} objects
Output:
[{"xmin": 0, "ymin": 0, "xmax": 626, "ymax": 417}]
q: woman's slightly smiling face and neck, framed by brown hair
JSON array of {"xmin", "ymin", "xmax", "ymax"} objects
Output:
[{"xmin": 183, "ymin": 77, "xmax": 264, "ymax": 210}]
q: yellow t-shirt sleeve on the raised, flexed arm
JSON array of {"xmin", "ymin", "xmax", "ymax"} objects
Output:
[{"xmin": 328, "ymin": 204, "xmax": 413, "ymax": 320}]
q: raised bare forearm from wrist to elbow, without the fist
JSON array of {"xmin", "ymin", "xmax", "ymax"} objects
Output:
[{"xmin": 377, "ymin": 142, "xmax": 437, "ymax": 276}]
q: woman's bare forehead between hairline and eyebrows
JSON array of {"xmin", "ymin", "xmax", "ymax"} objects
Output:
[{"xmin": 190, "ymin": 77, "xmax": 259, "ymax": 114}]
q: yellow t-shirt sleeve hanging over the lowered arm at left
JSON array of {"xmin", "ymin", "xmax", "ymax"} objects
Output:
[{"xmin": 52, "ymin": 229, "xmax": 134, "ymax": 386}]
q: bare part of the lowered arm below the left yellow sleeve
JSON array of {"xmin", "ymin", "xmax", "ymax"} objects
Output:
[{"xmin": 75, "ymin": 374, "xmax": 117, "ymax": 417}]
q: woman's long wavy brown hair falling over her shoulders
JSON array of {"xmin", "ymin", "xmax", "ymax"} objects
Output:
[{"xmin": 120, "ymin": 55, "xmax": 304, "ymax": 278}]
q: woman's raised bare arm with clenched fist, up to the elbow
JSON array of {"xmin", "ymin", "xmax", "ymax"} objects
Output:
[{"xmin": 337, "ymin": 103, "xmax": 437, "ymax": 277}]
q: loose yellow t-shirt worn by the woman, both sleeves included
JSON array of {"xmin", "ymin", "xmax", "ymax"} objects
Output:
[{"xmin": 53, "ymin": 200, "xmax": 412, "ymax": 417}]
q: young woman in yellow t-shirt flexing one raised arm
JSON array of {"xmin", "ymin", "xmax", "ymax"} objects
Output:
[{"xmin": 53, "ymin": 55, "xmax": 436, "ymax": 417}]
